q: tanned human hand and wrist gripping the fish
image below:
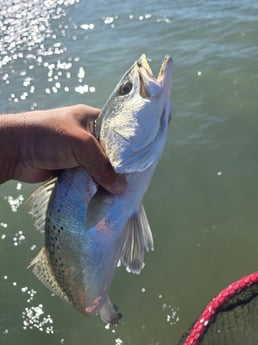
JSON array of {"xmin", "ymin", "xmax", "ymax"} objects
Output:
[{"xmin": 0, "ymin": 105, "xmax": 126, "ymax": 194}]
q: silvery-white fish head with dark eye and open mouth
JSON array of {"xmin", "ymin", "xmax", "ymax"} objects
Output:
[{"xmin": 95, "ymin": 54, "xmax": 172, "ymax": 174}]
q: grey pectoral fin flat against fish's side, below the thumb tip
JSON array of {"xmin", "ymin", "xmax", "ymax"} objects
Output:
[{"xmin": 85, "ymin": 187, "xmax": 115, "ymax": 229}]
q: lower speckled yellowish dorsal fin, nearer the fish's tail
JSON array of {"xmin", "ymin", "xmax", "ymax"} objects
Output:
[{"xmin": 28, "ymin": 247, "xmax": 70, "ymax": 303}]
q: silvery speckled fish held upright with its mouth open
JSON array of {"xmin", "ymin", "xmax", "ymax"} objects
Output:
[{"xmin": 29, "ymin": 54, "xmax": 172, "ymax": 324}]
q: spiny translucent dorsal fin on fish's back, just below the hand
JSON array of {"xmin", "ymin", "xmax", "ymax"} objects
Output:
[{"xmin": 25, "ymin": 177, "xmax": 57, "ymax": 232}]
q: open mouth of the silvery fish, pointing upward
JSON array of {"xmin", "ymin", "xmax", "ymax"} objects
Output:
[{"xmin": 136, "ymin": 54, "xmax": 173, "ymax": 98}]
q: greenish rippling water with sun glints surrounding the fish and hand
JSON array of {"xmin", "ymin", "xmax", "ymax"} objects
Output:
[{"xmin": 0, "ymin": 0, "xmax": 258, "ymax": 345}]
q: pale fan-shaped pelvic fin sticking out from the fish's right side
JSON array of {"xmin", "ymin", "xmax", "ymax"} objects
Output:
[{"xmin": 120, "ymin": 206, "xmax": 154, "ymax": 274}]
